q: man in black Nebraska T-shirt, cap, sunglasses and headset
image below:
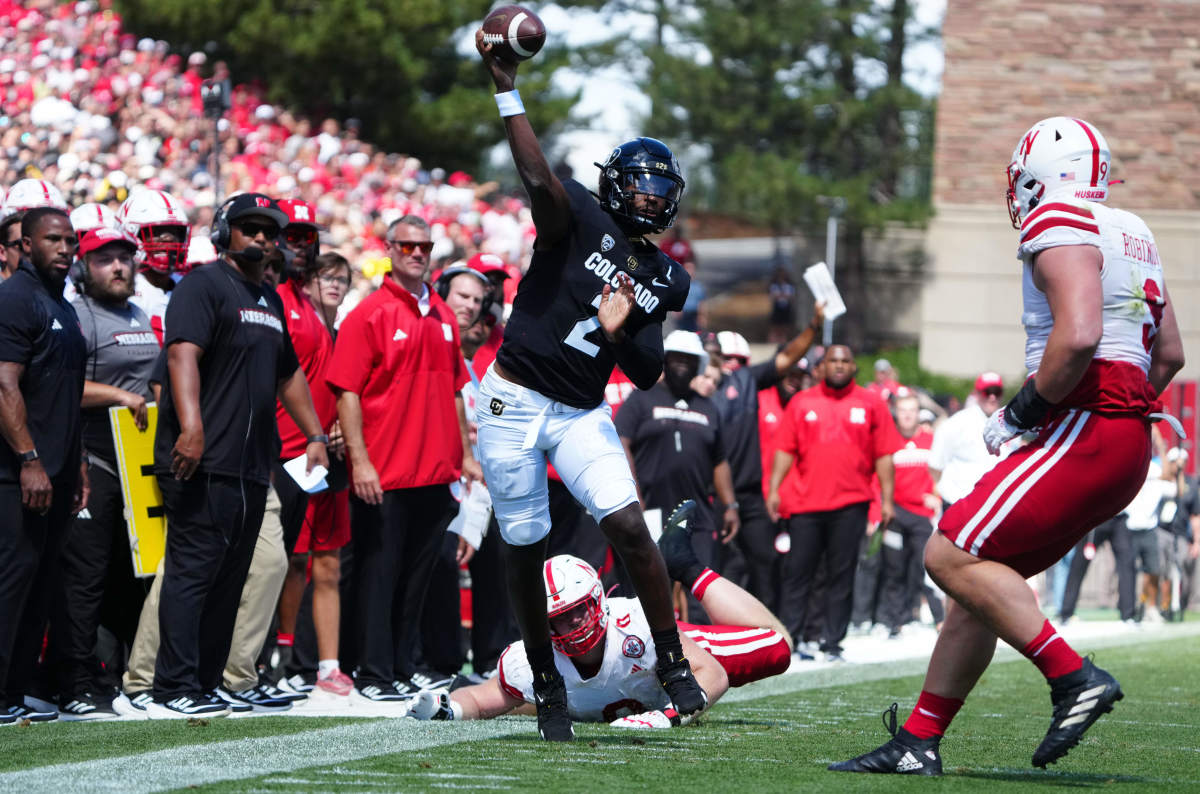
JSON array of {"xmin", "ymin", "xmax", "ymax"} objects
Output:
[{"xmin": 146, "ymin": 193, "xmax": 329, "ymax": 718}]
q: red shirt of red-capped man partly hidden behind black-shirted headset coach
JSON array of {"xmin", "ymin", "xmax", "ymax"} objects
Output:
[{"xmin": 275, "ymin": 279, "xmax": 337, "ymax": 461}]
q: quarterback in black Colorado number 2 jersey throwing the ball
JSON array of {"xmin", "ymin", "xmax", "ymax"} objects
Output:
[{"xmin": 475, "ymin": 30, "xmax": 704, "ymax": 741}]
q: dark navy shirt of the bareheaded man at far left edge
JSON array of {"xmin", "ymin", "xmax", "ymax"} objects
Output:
[{"xmin": 0, "ymin": 259, "xmax": 88, "ymax": 482}]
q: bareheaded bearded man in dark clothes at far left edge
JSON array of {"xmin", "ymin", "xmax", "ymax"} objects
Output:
[{"xmin": 0, "ymin": 207, "xmax": 88, "ymax": 724}]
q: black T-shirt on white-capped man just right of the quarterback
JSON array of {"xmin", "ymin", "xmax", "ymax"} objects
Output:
[{"xmin": 614, "ymin": 383, "xmax": 725, "ymax": 529}]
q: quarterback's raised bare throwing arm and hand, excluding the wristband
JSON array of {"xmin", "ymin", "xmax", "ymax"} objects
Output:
[{"xmin": 475, "ymin": 28, "xmax": 571, "ymax": 249}]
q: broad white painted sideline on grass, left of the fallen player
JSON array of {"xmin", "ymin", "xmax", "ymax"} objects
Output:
[{"xmin": 0, "ymin": 718, "xmax": 525, "ymax": 794}]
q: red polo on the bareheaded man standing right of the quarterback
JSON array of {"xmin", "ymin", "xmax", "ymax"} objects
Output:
[{"xmin": 776, "ymin": 383, "xmax": 901, "ymax": 517}]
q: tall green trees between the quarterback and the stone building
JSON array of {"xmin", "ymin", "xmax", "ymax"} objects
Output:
[{"xmin": 561, "ymin": 0, "xmax": 934, "ymax": 347}]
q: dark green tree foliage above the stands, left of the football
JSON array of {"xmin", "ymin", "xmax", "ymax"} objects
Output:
[{"xmin": 116, "ymin": 0, "xmax": 575, "ymax": 168}]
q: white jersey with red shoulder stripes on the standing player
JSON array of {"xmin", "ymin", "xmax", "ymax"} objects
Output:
[{"xmin": 1018, "ymin": 199, "xmax": 1166, "ymax": 372}]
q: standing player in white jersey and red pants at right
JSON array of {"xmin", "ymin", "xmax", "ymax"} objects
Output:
[{"xmin": 830, "ymin": 116, "xmax": 1183, "ymax": 775}]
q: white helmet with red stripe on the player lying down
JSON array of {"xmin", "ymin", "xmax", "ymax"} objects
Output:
[{"xmin": 542, "ymin": 554, "xmax": 608, "ymax": 656}]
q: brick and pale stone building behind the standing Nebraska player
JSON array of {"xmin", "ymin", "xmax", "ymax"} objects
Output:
[{"xmin": 920, "ymin": 0, "xmax": 1200, "ymax": 379}]
